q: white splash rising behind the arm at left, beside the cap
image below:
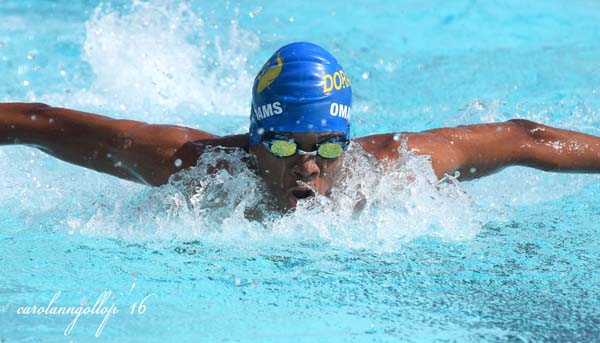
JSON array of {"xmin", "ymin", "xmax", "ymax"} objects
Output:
[{"xmin": 42, "ymin": 0, "xmax": 259, "ymax": 122}]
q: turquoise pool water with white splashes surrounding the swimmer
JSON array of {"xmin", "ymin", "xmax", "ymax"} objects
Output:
[{"xmin": 0, "ymin": 0, "xmax": 600, "ymax": 342}]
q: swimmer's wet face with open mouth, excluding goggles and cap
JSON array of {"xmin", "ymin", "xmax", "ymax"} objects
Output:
[{"xmin": 250, "ymin": 133, "xmax": 343, "ymax": 209}]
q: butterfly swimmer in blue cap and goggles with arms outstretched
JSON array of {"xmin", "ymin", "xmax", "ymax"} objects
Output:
[{"xmin": 0, "ymin": 43, "xmax": 600, "ymax": 209}]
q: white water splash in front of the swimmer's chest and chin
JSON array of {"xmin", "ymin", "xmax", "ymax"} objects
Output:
[{"xmin": 61, "ymin": 144, "xmax": 481, "ymax": 251}]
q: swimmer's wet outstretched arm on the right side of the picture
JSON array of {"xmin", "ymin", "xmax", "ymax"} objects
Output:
[{"xmin": 363, "ymin": 119, "xmax": 600, "ymax": 180}]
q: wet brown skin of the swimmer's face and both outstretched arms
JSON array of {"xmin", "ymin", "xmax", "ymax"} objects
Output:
[{"xmin": 0, "ymin": 103, "xmax": 600, "ymax": 209}]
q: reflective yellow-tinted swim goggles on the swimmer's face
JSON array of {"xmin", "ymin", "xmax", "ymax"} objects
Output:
[{"xmin": 263, "ymin": 135, "xmax": 349, "ymax": 158}]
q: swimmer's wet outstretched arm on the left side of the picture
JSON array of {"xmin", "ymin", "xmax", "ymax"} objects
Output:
[{"xmin": 0, "ymin": 103, "xmax": 247, "ymax": 186}]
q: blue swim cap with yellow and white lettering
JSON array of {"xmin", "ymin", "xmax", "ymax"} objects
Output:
[{"xmin": 250, "ymin": 42, "xmax": 352, "ymax": 145}]
